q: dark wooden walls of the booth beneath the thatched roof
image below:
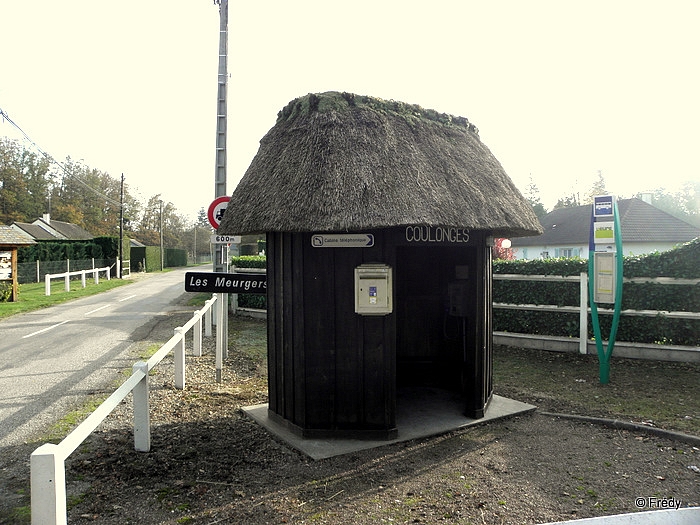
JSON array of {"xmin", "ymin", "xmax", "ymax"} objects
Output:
[{"xmin": 267, "ymin": 226, "xmax": 493, "ymax": 438}]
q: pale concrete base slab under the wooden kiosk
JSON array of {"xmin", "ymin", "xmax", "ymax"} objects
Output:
[{"xmin": 243, "ymin": 388, "xmax": 537, "ymax": 460}]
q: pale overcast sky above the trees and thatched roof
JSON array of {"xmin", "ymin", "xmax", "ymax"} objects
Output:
[{"xmin": 0, "ymin": 0, "xmax": 700, "ymax": 219}]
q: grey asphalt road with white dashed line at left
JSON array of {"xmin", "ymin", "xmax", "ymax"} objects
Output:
[{"xmin": 0, "ymin": 268, "xmax": 200, "ymax": 446}]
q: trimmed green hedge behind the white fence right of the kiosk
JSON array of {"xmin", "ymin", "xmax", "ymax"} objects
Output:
[{"xmin": 493, "ymin": 243, "xmax": 700, "ymax": 346}]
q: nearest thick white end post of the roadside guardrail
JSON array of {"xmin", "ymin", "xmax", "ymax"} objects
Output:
[{"xmin": 30, "ymin": 443, "xmax": 68, "ymax": 525}]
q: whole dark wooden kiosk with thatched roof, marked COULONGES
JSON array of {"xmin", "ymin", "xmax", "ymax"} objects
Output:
[{"xmin": 218, "ymin": 92, "xmax": 541, "ymax": 439}]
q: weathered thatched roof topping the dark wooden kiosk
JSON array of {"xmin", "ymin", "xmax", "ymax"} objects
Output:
[{"xmin": 218, "ymin": 92, "xmax": 542, "ymax": 237}]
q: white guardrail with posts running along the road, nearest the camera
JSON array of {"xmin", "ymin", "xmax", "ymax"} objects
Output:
[{"xmin": 30, "ymin": 292, "xmax": 221, "ymax": 525}]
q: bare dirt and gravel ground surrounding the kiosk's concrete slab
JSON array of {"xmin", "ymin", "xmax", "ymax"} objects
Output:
[{"xmin": 0, "ymin": 298, "xmax": 700, "ymax": 525}]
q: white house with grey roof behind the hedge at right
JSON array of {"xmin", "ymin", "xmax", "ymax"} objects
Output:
[{"xmin": 511, "ymin": 198, "xmax": 700, "ymax": 259}]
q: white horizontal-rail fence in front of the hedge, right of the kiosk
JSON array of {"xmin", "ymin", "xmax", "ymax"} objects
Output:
[{"xmin": 493, "ymin": 272, "xmax": 700, "ymax": 354}]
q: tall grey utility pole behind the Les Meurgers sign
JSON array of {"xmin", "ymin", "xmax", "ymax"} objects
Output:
[{"xmin": 214, "ymin": 0, "xmax": 228, "ymax": 372}]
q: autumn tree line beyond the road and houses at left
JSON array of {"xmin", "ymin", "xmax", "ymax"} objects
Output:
[{"xmin": 0, "ymin": 137, "xmax": 212, "ymax": 253}]
